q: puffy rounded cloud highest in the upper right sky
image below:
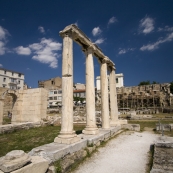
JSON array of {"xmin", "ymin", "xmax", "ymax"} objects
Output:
[{"xmin": 139, "ymin": 17, "xmax": 154, "ymax": 34}]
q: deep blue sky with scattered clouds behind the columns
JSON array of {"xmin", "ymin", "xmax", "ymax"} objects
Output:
[{"xmin": 0, "ymin": 0, "xmax": 173, "ymax": 88}]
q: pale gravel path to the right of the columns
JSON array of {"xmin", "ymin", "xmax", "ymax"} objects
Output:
[{"xmin": 73, "ymin": 132, "xmax": 157, "ymax": 173}]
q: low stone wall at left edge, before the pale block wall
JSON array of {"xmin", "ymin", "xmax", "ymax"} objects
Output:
[{"xmin": 0, "ymin": 122, "xmax": 42, "ymax": 134}]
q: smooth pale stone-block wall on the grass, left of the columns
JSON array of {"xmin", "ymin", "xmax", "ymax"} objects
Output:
[{"xmin": 12, "ymin": 88, "xmax": 48, "ymax": 123}]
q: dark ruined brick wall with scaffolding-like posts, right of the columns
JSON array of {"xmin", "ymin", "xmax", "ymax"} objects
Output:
[{"xmin": 117, "ymin": 83, "xmax": 171, "ymax": 109}]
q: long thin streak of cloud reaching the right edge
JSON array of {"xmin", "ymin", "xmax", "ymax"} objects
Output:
[{"xmin": 140, "ymin": 32, "xmax": 173, "ymax": 51}]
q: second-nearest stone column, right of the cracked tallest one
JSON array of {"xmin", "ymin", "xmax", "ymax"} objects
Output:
[{"xmin": 83, "ymin": 47, "xmax": 99, "ymax": 135}]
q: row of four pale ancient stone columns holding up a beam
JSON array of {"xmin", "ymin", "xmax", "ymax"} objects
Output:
[{"xmin": 54, "ymin": 32, "xmax": 118, "ymax": 144}]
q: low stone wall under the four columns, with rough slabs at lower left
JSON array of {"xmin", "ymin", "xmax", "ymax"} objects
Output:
[{"xmin": 0, "ymin": 126, "xmax": 122, "ymax": 173}]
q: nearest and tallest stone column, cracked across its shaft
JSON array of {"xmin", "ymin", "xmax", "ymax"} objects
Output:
[{"xmin": 54, "ymin": 32, "xmax": 80, "ymax": 144}]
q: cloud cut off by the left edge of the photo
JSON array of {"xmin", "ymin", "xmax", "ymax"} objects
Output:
[{"xmin": 0, "ymin": 26, "xmax": 10, "ymax": 55}]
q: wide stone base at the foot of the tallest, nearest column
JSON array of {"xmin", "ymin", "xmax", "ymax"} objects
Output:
[{"xmin": 54, "ymin": 135, "xmax": 81, "ymax": 144}]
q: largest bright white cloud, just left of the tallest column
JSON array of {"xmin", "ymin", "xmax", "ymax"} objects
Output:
[{"xmin": 29, "ymin": 38, "xmax": 62, "ymax": 68}]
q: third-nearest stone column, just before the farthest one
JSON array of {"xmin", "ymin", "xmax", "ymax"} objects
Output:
[{"xmin": 100, "ymin": 58, "xmax": 110, "ymax": 129}]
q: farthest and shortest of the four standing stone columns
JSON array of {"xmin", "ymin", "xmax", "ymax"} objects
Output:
[{"xmin": 109, "ymin": 67, "xmax": 118, "ymax": 126}]
